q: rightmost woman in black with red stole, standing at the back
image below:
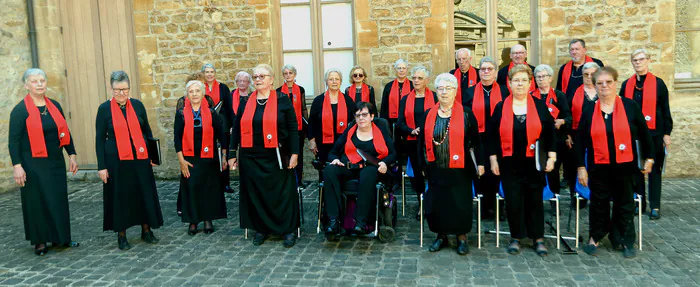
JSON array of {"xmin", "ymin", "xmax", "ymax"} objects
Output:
[{"xmin": 620, "ymin": 49, "xmax": 673, "ymax": 220}]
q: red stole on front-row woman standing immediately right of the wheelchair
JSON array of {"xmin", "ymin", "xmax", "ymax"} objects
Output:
[{"xmin": 424, "ymin": 103, "xmax": 466, "ymax": 168}]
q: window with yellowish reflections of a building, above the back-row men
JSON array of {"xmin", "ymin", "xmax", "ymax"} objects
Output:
[{"xmin": 454, "ymin": 0, "xmax": 539, "ymax": 67}]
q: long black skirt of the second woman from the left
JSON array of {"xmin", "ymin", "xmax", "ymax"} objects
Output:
[{"xmin": 102, "ymin": 147, "xmax": 163, "ymax": 232}]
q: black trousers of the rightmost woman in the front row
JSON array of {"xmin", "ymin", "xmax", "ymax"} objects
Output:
[{"xmin": 588, "ymin": 167, "xmax": 637, "ymax": 248}]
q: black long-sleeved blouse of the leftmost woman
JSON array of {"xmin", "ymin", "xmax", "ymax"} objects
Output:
[{"xmin": 8, "ymin": 99, "xmax": 75, "ymax": 165}]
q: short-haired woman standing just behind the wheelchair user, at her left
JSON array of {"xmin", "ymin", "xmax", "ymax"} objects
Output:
[{"xmin": 309, "ymin": 68, "xmax": 355, "ymax": 182}]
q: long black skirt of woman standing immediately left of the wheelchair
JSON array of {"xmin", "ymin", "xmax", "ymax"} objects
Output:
[{"xmin": 238, "ymin": 147, "xmax": 300, "ymax": 234}]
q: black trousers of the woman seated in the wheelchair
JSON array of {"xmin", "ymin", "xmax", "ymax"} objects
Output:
[{"xmin": 323, "ymin": 165, "xmax": 379, "ymax": 221}]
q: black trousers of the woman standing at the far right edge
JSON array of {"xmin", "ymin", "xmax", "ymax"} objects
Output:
[{"xmin": 636, "ymin": 135, "xmax": 666, "ymax": 210}]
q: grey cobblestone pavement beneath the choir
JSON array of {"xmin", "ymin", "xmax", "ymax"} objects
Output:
[{"xmin": 0, "ymin": 179, "xmax": 700, "ymax": 286}]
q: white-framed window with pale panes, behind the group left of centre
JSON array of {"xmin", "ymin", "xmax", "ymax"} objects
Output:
[{"xmin": 279, "ymin": 0, "xmax": 355, "ymax": 97}]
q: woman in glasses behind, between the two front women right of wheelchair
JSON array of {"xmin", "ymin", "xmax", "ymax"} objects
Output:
[{"xmin": 462, "ymin": 57, "xmax": 510, "ymax": 221}]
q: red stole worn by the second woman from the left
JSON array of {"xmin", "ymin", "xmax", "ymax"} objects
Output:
[{"xmin": 110, "ymin": 98, "xmax": 148, "ymax": 160}]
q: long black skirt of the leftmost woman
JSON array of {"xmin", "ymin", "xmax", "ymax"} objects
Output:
[{"xmin": 21, "ymin": 149, "xmax": 71, "ymax": 245}]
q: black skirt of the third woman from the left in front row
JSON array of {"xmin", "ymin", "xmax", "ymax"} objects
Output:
[{"xmin": 180, "ymin": 156, "xmax": 228, "ymax": 223}]
